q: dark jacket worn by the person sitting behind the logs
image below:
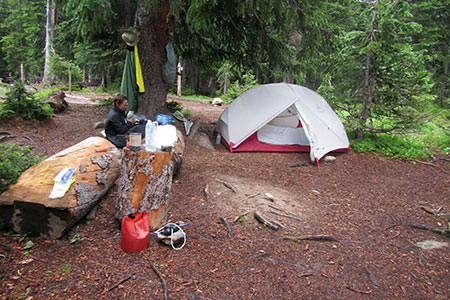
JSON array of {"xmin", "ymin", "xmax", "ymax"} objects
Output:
[{"xmin": 105, "ymin": 107, "xmax": 134, "ymax": 148}]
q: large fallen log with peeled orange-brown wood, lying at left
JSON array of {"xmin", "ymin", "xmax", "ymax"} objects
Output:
[{"xmin": 0, "ymin": 137, "xmax": 120, "ymax": 239}]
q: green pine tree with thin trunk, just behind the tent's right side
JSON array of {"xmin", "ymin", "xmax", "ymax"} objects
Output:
[{"xmin": 331, "ymin": 0, "xmax": 433, "ymax": 138}]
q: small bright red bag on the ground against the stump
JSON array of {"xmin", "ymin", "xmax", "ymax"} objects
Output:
[{"xmin": 120, "ymin": 211, "xmax": 150, "ymax": 253}]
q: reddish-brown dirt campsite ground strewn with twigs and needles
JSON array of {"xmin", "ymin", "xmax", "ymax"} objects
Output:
[{"xmin": 0, "ymin": 92, "xmax": 450, "ymax": 299}]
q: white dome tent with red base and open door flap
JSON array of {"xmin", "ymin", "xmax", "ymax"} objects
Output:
[{"xmin": 217, "ymin": 83, "xmax": 350, "ymax": 161}]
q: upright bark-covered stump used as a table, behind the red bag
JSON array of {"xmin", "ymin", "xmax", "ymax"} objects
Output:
[{"xmin": 116, "ymin": 130, "xmax": 184, "ymax": 231}]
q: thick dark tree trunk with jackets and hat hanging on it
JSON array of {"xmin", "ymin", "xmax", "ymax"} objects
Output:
[{"xmin": 135, "ymin": 0, "xmax": 175, "ymax": 120}]
